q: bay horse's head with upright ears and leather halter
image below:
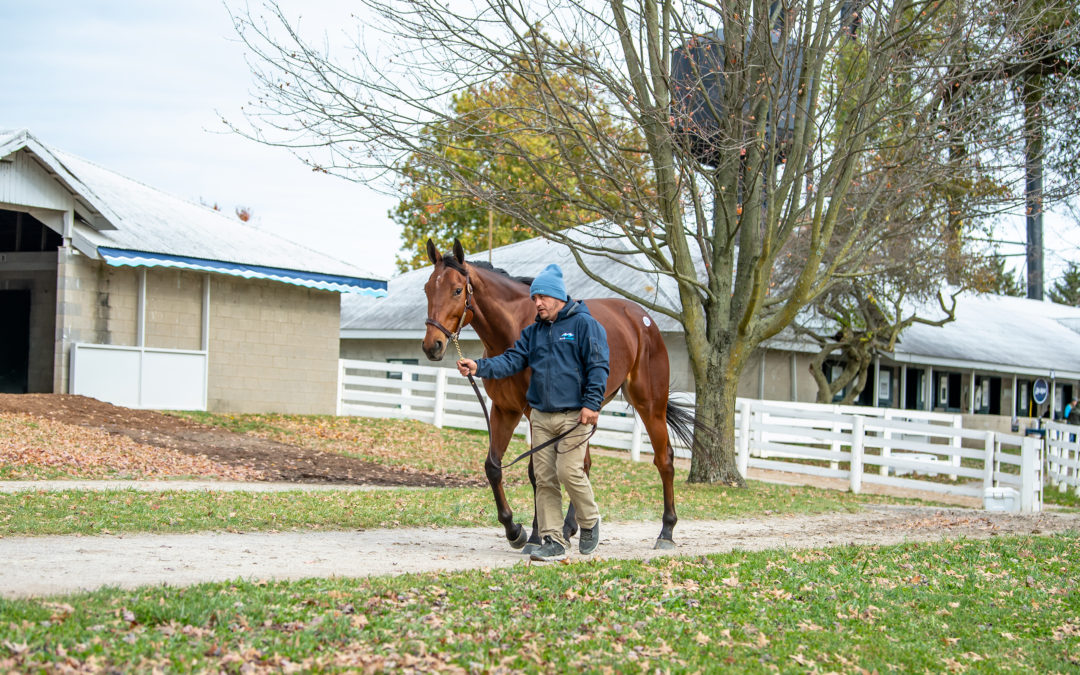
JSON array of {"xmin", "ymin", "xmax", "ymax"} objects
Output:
[{"xmin": 423, "ymin": 239, "xmax": 472, "ymax": 361}]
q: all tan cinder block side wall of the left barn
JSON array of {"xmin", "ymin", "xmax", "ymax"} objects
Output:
[{"xmin": 53, "ymin": 252, "xmax": 340, "ymax": 415}]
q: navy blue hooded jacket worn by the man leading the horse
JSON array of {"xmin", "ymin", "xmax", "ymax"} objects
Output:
[{"xmin": 476, "ymin": 300, "xmax": 609, "ymax": 413}]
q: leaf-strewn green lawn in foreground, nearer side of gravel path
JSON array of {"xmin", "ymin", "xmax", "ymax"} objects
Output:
[{"xmin": 0, "ymin": 534, "xmax": 1080, "ymax": 674}]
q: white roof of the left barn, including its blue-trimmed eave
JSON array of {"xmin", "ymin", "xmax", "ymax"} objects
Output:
[{"xmin": 0, "ymin": 130, "xmax": 387, "ymax": 296}]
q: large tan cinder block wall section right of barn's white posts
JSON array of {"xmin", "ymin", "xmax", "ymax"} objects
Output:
[{"xmin": 207, "ymin": 276, "xmax": 340, "ymax": 415}]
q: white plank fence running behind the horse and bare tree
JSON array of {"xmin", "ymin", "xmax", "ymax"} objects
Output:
[{"xmin": 338, "ymin": 361, "xmax": 1045, "ymax": 512}]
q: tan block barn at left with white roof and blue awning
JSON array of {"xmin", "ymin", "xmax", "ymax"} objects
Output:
[{"xmin": 0, "ymin": 125, "xmax": 387, "ymax": 414}]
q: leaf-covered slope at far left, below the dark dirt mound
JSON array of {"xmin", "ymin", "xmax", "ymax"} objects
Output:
[{"xmin": 0, "ymin": 414, "xmax": 262, "ymax": 481}]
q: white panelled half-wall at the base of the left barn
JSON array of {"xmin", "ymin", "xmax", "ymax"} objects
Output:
[{"xmin": 68, "ymin": 342, "xmax": 207, "ymax": 410}]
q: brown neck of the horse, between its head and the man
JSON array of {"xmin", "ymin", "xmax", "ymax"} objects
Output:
[{"xmin": 472, "ymin": 268, "xmax": 534, "ymax": 354}]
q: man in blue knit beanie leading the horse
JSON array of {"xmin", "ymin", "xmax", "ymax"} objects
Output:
[{"xmin": 458, "ymin": 260, "xmax": 609, "ymax": 562}]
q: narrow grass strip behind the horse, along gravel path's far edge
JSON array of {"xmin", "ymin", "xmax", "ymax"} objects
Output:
[{"xmin": 0, "ymin": 457, "xmax": 900, "ymax": 537}]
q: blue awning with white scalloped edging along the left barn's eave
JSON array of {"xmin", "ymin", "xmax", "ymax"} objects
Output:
[{"xmin": 97, "ymin": 246, "xmax": 387, "ymax": 297}]
